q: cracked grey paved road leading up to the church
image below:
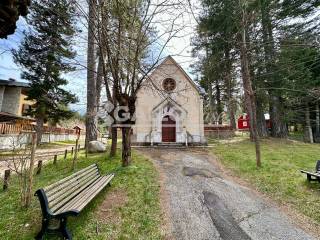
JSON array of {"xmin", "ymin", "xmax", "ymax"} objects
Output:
[{"xmin": 140, "ymin": 149, "xmax": 315, "ymax": 240}]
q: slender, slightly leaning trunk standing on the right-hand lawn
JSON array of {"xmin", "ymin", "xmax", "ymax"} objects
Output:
[{"xmin": 239, "ymin": 6, "xmax": 261, "ymax": 167}]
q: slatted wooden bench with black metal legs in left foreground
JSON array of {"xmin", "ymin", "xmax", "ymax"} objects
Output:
[{"xmin": 35, "ymin": 164, "xmax": 114, "ymax": 239}]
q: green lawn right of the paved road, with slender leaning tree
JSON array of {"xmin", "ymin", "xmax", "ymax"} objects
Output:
[{"xmin": 212, "ymin": 139, "xmax": 320, "ymax": 224}]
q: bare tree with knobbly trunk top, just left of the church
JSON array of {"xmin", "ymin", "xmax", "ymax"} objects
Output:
[{"xmin": 92, "ymin": 0, "xmax": 183, "ymax": 166}]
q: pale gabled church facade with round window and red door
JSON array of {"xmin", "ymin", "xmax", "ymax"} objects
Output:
[{"xmin": 132, "ymin": 56, "xmax": 206, "ymax": 145}]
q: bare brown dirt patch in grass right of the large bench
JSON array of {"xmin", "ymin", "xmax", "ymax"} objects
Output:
[{"xmin": 97, "ymin": 189, "xmax": 128, "ymax": 224}]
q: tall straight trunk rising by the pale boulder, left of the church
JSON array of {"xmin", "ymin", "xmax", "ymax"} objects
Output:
[{"xmin": 86, "ymin": 0, "xmax": 98, "ymax": 144}]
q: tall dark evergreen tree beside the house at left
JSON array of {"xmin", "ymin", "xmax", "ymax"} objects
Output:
[{"xmin": 13, "ymin": 0, "xmax": 77, "ymax": 143}]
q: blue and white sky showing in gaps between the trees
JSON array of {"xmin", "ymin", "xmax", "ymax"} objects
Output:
[{"xmin": 0, "ymin": 0, "xmax": 198, "ymax": 113}]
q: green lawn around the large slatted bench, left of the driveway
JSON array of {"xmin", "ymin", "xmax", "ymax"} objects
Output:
[{"xmin": 0, "ymin": 149, "xmax": 163, "ymax": 240}]
